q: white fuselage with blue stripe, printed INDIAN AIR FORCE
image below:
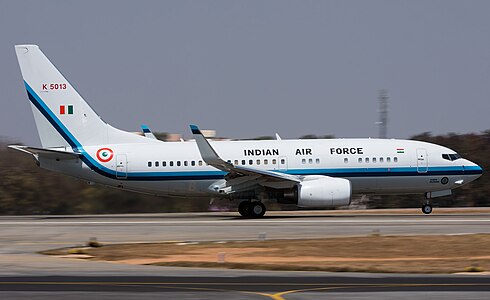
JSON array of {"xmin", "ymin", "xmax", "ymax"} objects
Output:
[{"xmin": 40, "ymin": 139, "xmax": 482, "ymax": 196}]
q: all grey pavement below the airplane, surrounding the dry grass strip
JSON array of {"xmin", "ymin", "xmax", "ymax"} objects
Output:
[{"xmin": 0, "ymin": 209, "xmax": 490, "ymax": 299}]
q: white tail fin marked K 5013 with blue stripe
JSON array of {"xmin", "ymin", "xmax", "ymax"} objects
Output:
[{"xmin": 15, "ymin": 45, "xmax": 148, "ymax": 149}]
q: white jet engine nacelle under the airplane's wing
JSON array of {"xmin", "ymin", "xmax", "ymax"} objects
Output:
[{"xmin": 298, "ymin": 175, "xmax": 352, "ymax": 208}]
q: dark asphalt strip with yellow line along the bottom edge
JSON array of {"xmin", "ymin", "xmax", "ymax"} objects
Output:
[{"xmin": 0, "ymin": 276, "xmax": 490, "ymax": 300}]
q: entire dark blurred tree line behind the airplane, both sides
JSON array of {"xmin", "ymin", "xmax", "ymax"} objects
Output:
[{"xmin": 0, "ymin": 130, "xmax": 490, "ymax": 215}]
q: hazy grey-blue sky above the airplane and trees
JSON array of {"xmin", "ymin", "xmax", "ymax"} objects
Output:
[{"xmin": 0, "ymin": 0, "xmax": 490, "ymax": 145}]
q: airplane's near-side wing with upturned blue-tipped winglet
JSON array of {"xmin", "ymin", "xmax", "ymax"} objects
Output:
[{"xmin": 190, "ymin": 125, "xmax": 301, "ymax": 189}]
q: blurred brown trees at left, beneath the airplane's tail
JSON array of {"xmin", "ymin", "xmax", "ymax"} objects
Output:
[{"xmin": 0, "ymin": 141, "xmax": 209, "ymax": 215}]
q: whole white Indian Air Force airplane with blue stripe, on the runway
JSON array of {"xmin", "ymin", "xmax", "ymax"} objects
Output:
[{"xmin": 9, "ymin": 45, "xmax": 483, "ymax": 218}]
